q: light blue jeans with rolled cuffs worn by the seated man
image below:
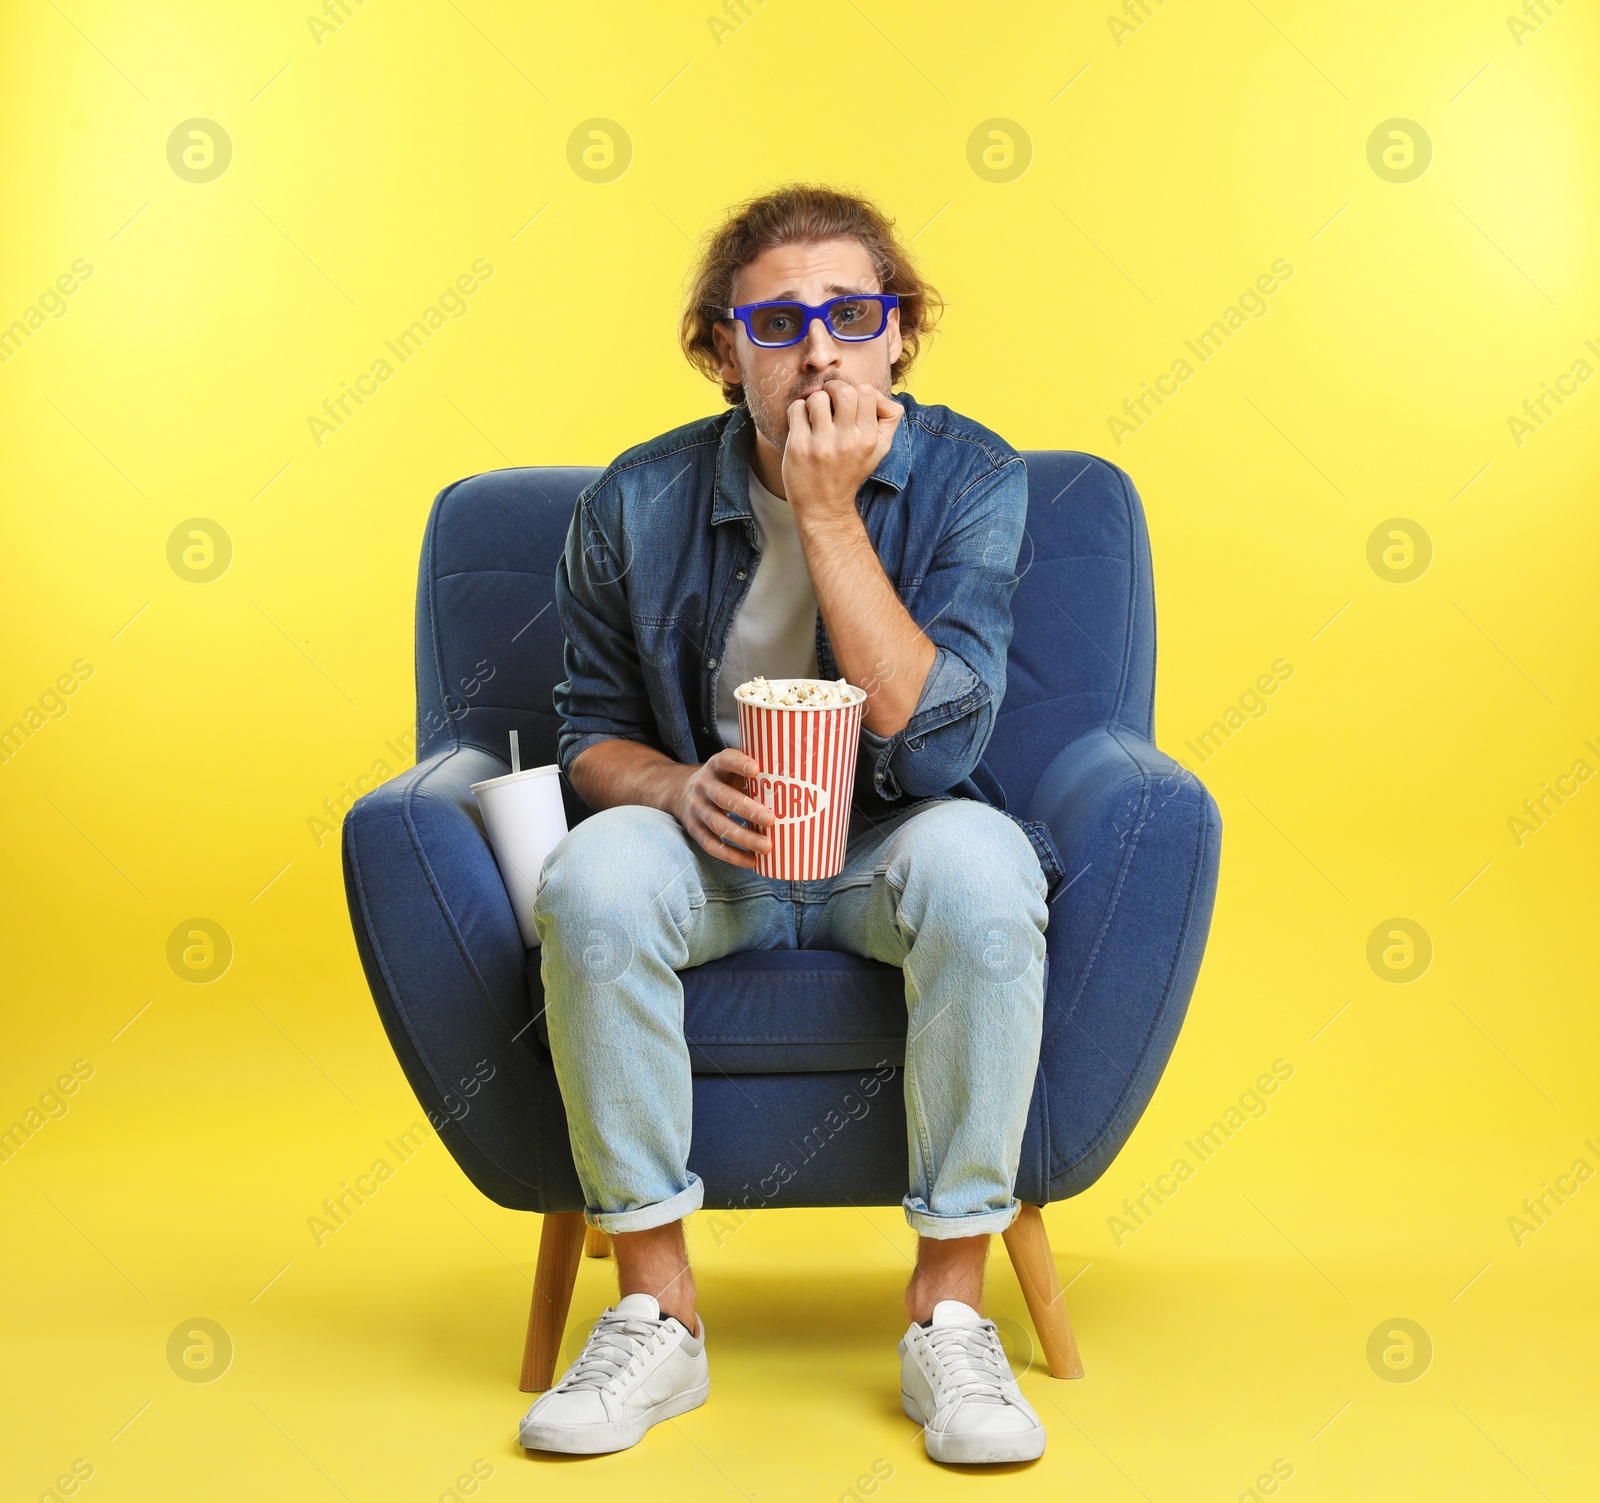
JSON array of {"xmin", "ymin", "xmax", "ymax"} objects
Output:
[{"xmin": 534, "ymin": 799, "xmax": 1048, "ymax": 1237}]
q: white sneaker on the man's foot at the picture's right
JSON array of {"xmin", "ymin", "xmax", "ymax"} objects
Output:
[{"xmin": 899, "ymin": 1300, "xmax": 1045, "ymax": 1461}]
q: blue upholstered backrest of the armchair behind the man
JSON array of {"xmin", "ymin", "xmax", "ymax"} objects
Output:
[{"xmin": 416, "ymin": 450, "xmax": 1155, "ymax": 820}]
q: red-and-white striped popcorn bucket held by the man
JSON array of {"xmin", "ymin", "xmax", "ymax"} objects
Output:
[{"xmin": 736, "ymin": 679, "xmax": 867, "ymax": 882}]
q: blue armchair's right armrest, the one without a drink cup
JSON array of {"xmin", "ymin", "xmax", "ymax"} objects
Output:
[{"xmin": 1027, "ymin": 725, "xmax": 1222, "ymax": 1199}]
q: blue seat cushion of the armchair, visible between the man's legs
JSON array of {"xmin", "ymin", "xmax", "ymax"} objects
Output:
[{"xmin": 528, "ymin": 949, "xmax": 906, "ymax": 1076}]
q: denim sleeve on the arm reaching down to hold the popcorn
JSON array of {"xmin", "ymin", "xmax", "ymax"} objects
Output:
[{"xmin": 554, "ymin": 475, "xmax": 661, "ymax": 781}]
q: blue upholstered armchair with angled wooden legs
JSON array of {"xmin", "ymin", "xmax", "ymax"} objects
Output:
[{"xmin": 342, "ymin": 450, "xmax": 1221, "ymax": 1391}]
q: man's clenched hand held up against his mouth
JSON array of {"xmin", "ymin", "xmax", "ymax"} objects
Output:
[{"xmin": 782, "ymin": 381, "xmax": 906, "ymax": 523}]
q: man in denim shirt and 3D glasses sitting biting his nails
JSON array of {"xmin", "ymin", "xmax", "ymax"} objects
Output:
[{"xmin": 522, "ymin": 184, "xmax": 1061, "ymax": 1461}]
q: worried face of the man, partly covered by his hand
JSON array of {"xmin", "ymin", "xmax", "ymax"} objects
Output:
[{"xmin": 712, "ymin": 240, "xmax": 901, "ymax": 451}]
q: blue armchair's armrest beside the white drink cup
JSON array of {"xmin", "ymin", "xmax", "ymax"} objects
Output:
[{"xmin": 342, "ymin": 746, "xmax": 571, "ymax": 1210}]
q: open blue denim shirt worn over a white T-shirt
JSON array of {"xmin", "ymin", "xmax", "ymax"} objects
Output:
[{"xmin": 555, "ymin": 392, "xmax": 1062, "ymax": 895}]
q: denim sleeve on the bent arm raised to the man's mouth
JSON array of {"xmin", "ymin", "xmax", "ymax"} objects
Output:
[{"xmin": 861, "ymin": 455, "xmax": 1027, "ymax": 800}]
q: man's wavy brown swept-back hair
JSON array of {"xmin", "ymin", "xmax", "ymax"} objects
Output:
[{"xmin": 678, "ymin": 182, "xmax": 944, "ymax": 407}]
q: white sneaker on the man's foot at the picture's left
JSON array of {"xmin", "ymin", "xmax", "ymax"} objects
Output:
[{"xmin": 518, "ymin": 1295, "xmax": 710, "ymax": 1455}]
